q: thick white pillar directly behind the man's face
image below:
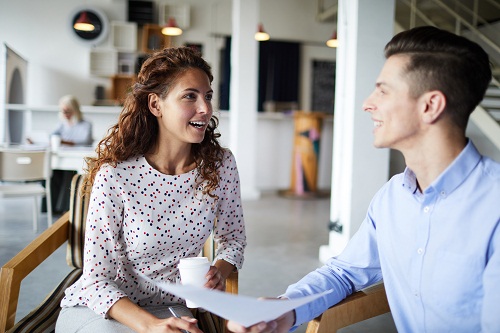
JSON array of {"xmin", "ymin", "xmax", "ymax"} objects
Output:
[{"xmin": 319, "ymin": 0, "xmax": 395, "ymax": 262}]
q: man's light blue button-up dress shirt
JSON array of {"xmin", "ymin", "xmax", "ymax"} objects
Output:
[{"xmin": 283, "ymin": 140, "xmax": 500, "ymax": 333}]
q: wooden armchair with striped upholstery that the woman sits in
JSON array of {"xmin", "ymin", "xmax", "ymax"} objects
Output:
[{"xmin": 0, "ymin": 175, "xmax": 238, "ymax": 333}]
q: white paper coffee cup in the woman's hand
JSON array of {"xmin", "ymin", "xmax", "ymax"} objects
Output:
[{"xmin": 178, "ymin": 257, "xmax": 210, "ymax": 308}]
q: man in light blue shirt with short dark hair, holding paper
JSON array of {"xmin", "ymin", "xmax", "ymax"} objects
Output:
[{"xmin": 228, "ymin": 27, "xmax": 500, "ymax": 332}]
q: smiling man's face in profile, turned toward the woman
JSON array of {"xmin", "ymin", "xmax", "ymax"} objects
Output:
[{"xmin": 363, "ymin": 55, "xmax": 421, "ymax": 151}]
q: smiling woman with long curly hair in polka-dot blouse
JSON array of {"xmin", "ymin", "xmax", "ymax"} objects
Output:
[{"xmin": 56, "ymin": 47, "xmax": 246, "ymax": 333}]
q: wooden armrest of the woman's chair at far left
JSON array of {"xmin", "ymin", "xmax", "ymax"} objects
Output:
[{"xmin": 0, "ymin": 212, "xmax": 69, "ymax": 332}]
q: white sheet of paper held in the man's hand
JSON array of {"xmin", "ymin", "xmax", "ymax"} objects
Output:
[{"xmin": 158, "ymin": 283, "xmax": 332, "ymax": 327}]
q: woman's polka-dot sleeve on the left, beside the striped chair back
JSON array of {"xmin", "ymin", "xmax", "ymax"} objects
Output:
[{"xmin": 80, "ymin": 166, "xmax": 127, "ymax": 317}]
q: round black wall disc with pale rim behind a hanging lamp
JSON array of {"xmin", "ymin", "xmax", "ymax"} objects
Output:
[{"xmin": 69, "ymin": 6, "xmax": 109, "ymax": 46}]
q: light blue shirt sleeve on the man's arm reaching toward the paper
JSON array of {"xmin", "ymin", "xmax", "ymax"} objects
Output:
[{"xmin": 281, "ymin": 204, "xmax": 382, "ymax": 328}]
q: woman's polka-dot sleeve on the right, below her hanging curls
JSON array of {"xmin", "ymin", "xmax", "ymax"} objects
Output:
[{"xmin": 214, "ymin": 151, "xmax": 246, "ymax": 269}]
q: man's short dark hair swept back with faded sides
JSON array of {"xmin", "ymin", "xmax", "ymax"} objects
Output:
[{"xmin": 385, "ymin": 26, "xmax": 491, "ymax": 130}]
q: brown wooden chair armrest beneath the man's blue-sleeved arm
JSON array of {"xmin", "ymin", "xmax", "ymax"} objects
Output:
[{"xmin": 306, "ymin": 283, "xmax": 391, "ymax": 333}]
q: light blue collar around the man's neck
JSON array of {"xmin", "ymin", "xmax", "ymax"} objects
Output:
[{"xmin": 402, "ymin": 140, "xmax": 481, "ymax": 196}]
